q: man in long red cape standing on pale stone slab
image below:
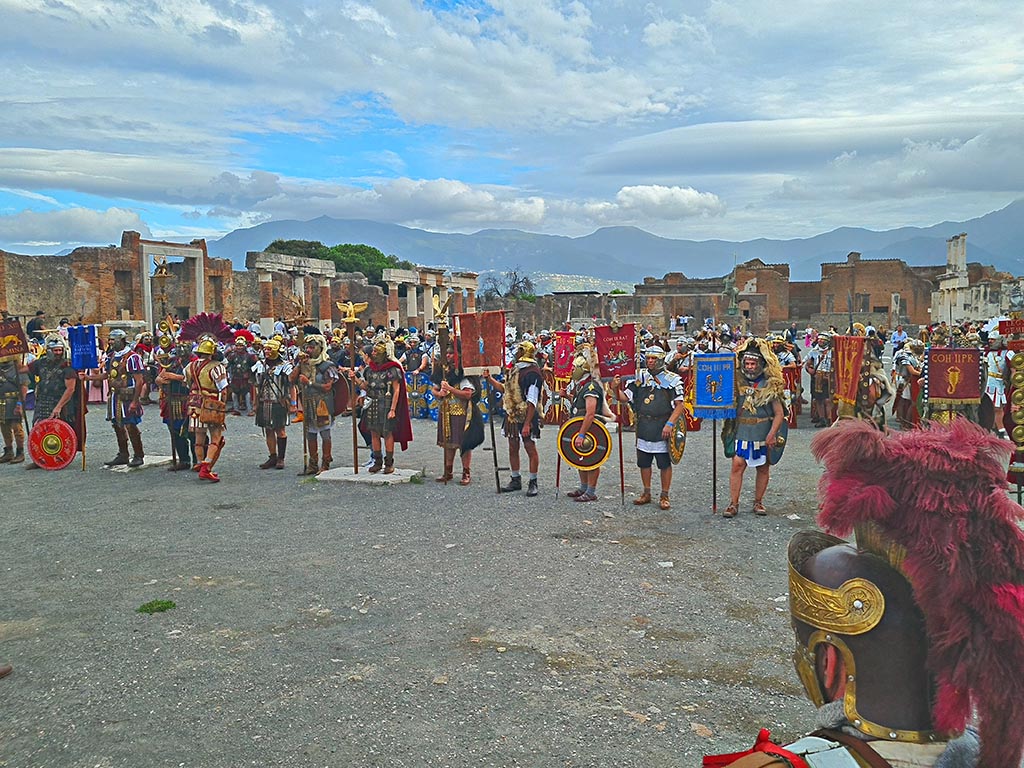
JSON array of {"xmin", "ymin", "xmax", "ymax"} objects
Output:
[{"xmin": 349, "ymin": 331, "xmax": 413, "ymax": 474}]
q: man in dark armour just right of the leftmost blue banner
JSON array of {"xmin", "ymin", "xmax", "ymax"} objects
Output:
[{"xmin": 80, "ymin": 328, "xmax": 145, "ymax": 467}]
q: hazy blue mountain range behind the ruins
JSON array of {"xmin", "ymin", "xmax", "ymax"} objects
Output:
[{"xmin": 207, "ymin": 200, "xmax": 1024, "ymax": 292}]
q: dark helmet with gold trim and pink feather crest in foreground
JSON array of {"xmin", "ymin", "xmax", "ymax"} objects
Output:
[{"xmin": 811, "ymin": 419, "xmax": 1024, "ymax": 768}]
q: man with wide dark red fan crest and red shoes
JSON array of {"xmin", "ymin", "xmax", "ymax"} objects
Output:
[{"xmin": 178, "ymin": 312, "xmax": 234, "ymax": 482}]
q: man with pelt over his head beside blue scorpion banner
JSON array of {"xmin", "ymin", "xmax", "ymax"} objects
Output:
[{"xmin": 722, "ymin": 337, "xmax": 785, "ymax": 517}]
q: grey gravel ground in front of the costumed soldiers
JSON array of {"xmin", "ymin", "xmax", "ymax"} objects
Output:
[{"xmin": 0, "ymin": 387, "xmax": 820, "ymax": 768}]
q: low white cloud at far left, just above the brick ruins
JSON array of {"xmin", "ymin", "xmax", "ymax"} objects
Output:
[{"xmin": 0, "ymin": 208, "xmax": 150, "ymax": 248}]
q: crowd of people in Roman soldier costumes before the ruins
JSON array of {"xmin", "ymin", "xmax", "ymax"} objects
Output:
[{"xmin": 0, "ymin": 313, "xmax": 1012, "ymax": 505}]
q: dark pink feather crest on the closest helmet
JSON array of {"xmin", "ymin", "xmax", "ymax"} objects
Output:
[{"xmin": 811, "ymin": 419, "xmax": 1024, "ymax": 768}]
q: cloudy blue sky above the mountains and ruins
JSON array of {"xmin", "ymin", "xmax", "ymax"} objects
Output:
[{"xmin": 0, "ymin": 0, "xmax": 1024, "ymax": 253}]
